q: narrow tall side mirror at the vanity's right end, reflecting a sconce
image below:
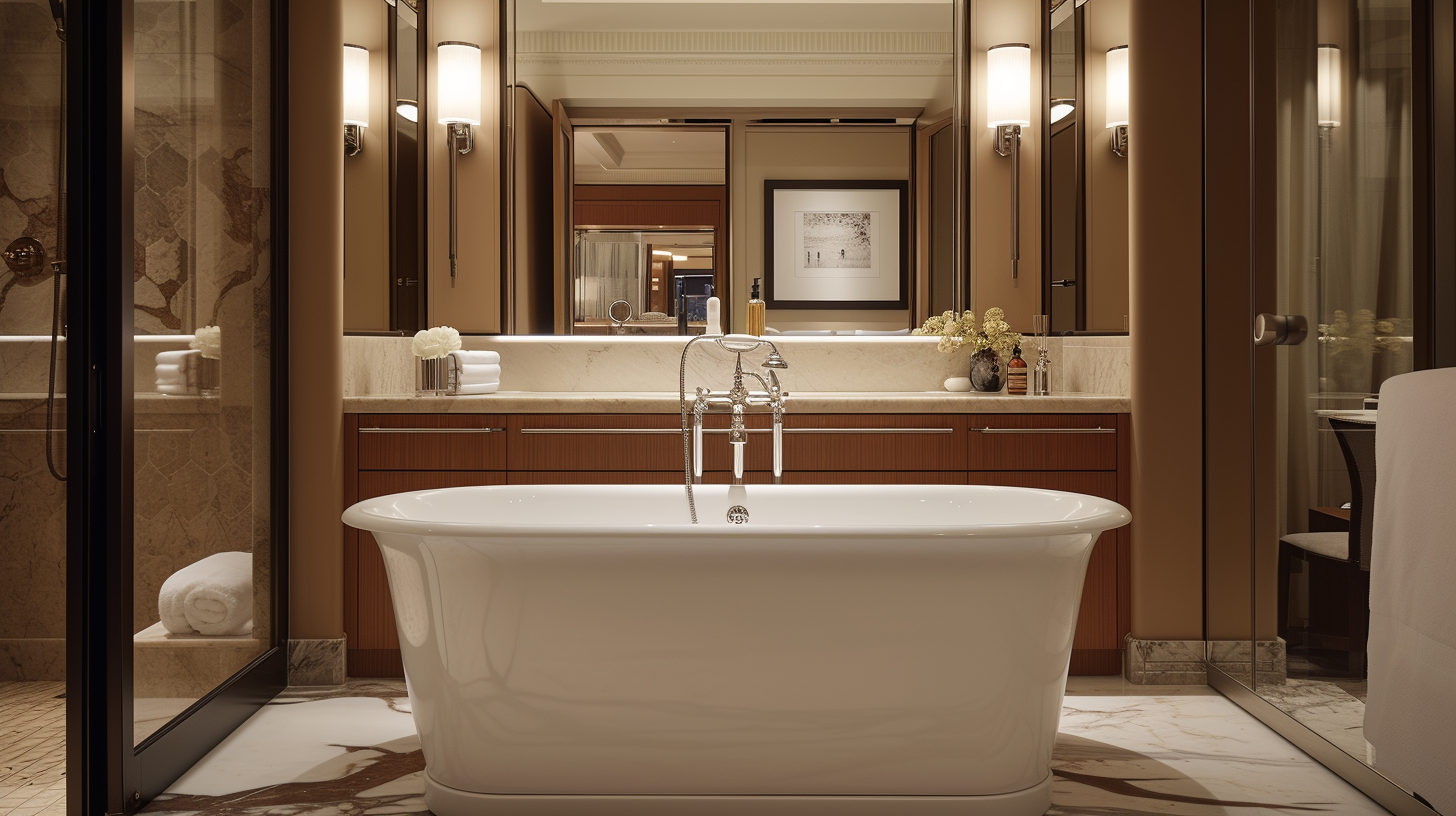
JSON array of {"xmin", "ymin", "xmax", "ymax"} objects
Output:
[{"xmin": 1041, "ymin": 0, "xmax": 1131, "ymax": 334}]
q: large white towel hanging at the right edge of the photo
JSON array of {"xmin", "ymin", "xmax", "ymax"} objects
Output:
[{"xmin": 1364, "ymin": 369, "xmax": 1456, "ymax": 815}]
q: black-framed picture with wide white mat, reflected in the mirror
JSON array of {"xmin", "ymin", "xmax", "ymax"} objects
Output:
[{"xmin": 763, "ymin": 179, "xmax": 910, "ymax": 309}]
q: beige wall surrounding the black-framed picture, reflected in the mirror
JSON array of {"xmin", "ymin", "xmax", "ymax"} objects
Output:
[{"xmin": 729, "ymin": 127, "xmax": 914, "ymax": 331}]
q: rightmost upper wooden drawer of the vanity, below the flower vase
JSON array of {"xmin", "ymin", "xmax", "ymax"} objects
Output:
[{"xmin": 967, "ymin": 414, "xmax": 1117, "ymax": 471}]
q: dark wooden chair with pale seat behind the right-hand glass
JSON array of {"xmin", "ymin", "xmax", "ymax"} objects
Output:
[{"xmin": 1278, "ymin": 420, "xmax": 1374, "ymax": 678}]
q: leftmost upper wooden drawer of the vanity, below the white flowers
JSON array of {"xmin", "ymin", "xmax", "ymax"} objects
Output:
[{"xmin": 358, "ymin": 414, "xmax": 505, "ymax": 471}]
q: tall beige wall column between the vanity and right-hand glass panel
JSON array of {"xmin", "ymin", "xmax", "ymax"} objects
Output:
[{"xmin": 1128, "ymin": 0, "xmax": 1205, "ymax": 640}]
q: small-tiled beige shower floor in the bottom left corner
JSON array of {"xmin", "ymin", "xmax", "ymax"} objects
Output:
[{"xmin": 0, "ymin": 680, "xmax": 66, "ymax": 816}]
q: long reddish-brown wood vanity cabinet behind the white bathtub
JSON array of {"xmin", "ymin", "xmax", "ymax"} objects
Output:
[{"xmin": 344, "ymin": 414, "xmax": 1131, "ymax": 678}]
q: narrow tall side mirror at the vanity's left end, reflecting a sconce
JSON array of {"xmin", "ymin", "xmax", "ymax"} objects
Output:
[{"xmin": 344, "ymin": 0, "xmax": 428, "ymax": 334}]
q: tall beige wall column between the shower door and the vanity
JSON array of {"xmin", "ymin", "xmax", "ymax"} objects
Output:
[{"xmin": 288, "ymin": 0, "xmax": 344, "ymax": 638}]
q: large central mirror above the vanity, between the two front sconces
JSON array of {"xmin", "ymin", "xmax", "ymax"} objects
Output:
[{"xmin": 502, "ymin": 0, "xmax": 955, "ymax": 335}]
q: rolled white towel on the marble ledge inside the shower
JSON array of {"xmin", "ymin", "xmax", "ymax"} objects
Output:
[{"xmin": 157, "ymin": 552, "xmax": 253, "ymax": 635}]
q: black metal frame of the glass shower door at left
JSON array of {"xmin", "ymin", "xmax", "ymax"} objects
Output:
[{"xmin": 63, "ymin": 0, "xmax": 288, "ymax": 816}]
